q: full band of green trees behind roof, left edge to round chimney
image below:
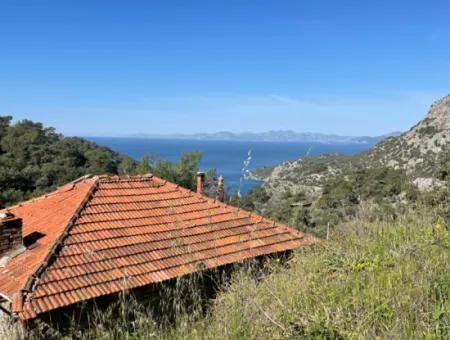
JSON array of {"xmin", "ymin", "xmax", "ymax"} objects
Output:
[{"xmin": 0, "ymin": 116, "xmax": 206, "ymax": 208}]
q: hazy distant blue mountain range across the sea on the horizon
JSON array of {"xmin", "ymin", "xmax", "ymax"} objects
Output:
[{"xmin": 119, "ymin": 130, "xmax": 401, "ymax": 144}]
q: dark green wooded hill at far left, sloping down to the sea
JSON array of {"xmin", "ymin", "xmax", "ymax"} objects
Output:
[{"xmin": 0, "ymin": 117, "xmax": 130, "ymax": 206}]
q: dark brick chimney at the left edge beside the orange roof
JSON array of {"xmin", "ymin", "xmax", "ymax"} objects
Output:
[{"xmin": 0, "ymin": 211, "xmax": 22, "ymax": 257}]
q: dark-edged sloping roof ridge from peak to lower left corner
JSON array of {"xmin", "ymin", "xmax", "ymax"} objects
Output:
[{"xmin": 11, "ymin": 177, "xmax": 99, "ymax": 313}]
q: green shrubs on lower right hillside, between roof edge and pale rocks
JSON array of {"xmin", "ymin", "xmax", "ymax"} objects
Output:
[{"xmin": 231, "ymin": 167, "xmax": 422, "ymax": 237}]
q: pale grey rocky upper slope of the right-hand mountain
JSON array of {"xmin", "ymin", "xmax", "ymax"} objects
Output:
[{"xmin": 254, "ymin": 95, "xmax": 450, "ymax": 195}]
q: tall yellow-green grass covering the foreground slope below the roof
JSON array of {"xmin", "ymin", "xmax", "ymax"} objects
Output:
[{"xmin": 1, "ymin": 209, "xmax": 450, "ymax": 339}]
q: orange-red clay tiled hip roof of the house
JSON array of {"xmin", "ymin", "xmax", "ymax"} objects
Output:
[{"xmin": 0, "ymin": 176, "xmax": 315, "ymax": 319}]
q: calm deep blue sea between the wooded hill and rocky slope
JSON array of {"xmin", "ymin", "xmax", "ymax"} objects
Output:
[{"xmin": 89, "ymin": 137, "xmax": 372, "ymax": 193}]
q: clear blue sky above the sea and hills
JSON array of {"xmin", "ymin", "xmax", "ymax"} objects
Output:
[{"xmin": 0, "ymin": 0, "xmax": 450, "ymax": 135}]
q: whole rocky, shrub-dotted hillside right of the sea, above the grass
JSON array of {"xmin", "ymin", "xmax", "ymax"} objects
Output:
[{"xmin": 243, "ymin": 96, "xmax": 450, "ymax": 236}]
